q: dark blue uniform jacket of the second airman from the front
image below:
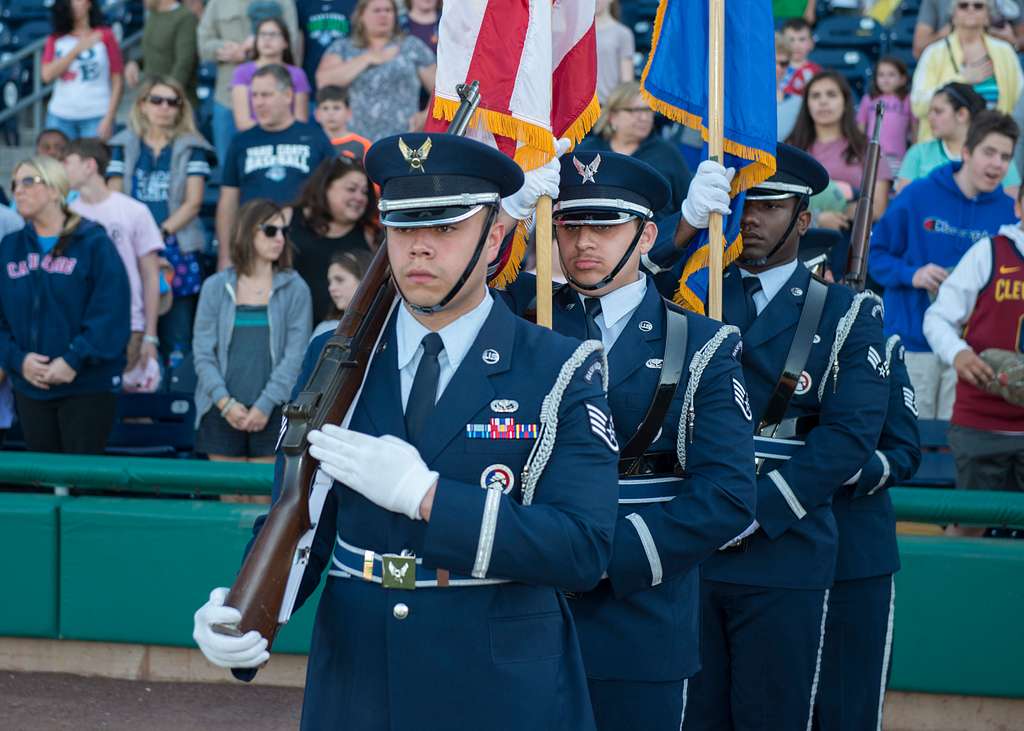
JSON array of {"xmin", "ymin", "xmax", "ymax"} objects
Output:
[{"xmin": 507, "ymin": 275, "xmax": 755, "ymax": 682}]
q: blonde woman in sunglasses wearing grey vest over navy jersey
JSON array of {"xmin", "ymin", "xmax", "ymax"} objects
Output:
[{"xmin": 106, "ymin": 76, "xmax": 215, "ymax": 364}]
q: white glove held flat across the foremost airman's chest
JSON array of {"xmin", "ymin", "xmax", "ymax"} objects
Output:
[{"xmin": 307, "ymin": 424, "xmax": 438, "ymax": 520}]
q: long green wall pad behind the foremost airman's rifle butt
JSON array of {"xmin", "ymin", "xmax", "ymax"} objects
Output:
[{"xmin": 59, "ymin": 498, "xmax": 318, "ymax": 652}]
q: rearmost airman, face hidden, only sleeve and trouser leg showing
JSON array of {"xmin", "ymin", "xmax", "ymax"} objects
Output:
[{"xmin": 814, "ymin": 335, "xmax": 921, "ymax": 731}]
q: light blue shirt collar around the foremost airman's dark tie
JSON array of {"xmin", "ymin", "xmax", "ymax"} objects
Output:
[{"xmin": 395, "ymin": 292, "xmax": 495, "ymax": 412}]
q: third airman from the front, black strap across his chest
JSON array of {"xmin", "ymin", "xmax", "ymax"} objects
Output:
[{"xmin": 667, "ymin": 144, "xmax": 889, "ymax": 731}]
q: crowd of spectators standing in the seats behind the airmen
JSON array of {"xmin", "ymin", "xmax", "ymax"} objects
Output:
[{"xmin": 0, "ymin": 0, "xmax": 1024, "ymax": 487}]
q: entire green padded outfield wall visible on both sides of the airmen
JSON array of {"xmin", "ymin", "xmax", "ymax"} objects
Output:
[{"xmin": 6, "ymin": 493, "xmax": 1024, "ymax": 697}]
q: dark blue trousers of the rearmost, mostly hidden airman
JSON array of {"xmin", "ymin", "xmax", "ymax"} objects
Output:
[{"xmin": 814, "ymin": 575, "xmax": 896, "ymax": 731}]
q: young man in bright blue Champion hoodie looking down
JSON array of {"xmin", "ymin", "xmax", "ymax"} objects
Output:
[{"xmin": 868, "ymin": 111, "xmax": 1019, "ymax": 420}]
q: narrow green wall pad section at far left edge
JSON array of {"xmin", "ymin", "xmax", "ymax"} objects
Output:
[{"xmin": 0, "ymin": 493, "xmax": 61, "ymax": 637}]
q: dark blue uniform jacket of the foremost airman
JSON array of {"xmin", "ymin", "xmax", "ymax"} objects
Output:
[{"xmin": 257, "ymin": 292, "xmax": 616, "ymax": 731}]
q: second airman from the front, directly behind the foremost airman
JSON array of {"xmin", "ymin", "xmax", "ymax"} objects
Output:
[{"xmin": 499, "ymin": 152, "xmax": 755, "ymax": 731}]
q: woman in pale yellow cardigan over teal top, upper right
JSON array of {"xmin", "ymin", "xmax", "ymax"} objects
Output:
[{"xmin": 910, "ymin": 0, "xmax": 1024, "ymax": 142}]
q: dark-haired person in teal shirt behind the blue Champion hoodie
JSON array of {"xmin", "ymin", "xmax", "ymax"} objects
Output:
[{"xmin": 895, "ymin": 83, "xmax": 1021, "ymax": 193}]
